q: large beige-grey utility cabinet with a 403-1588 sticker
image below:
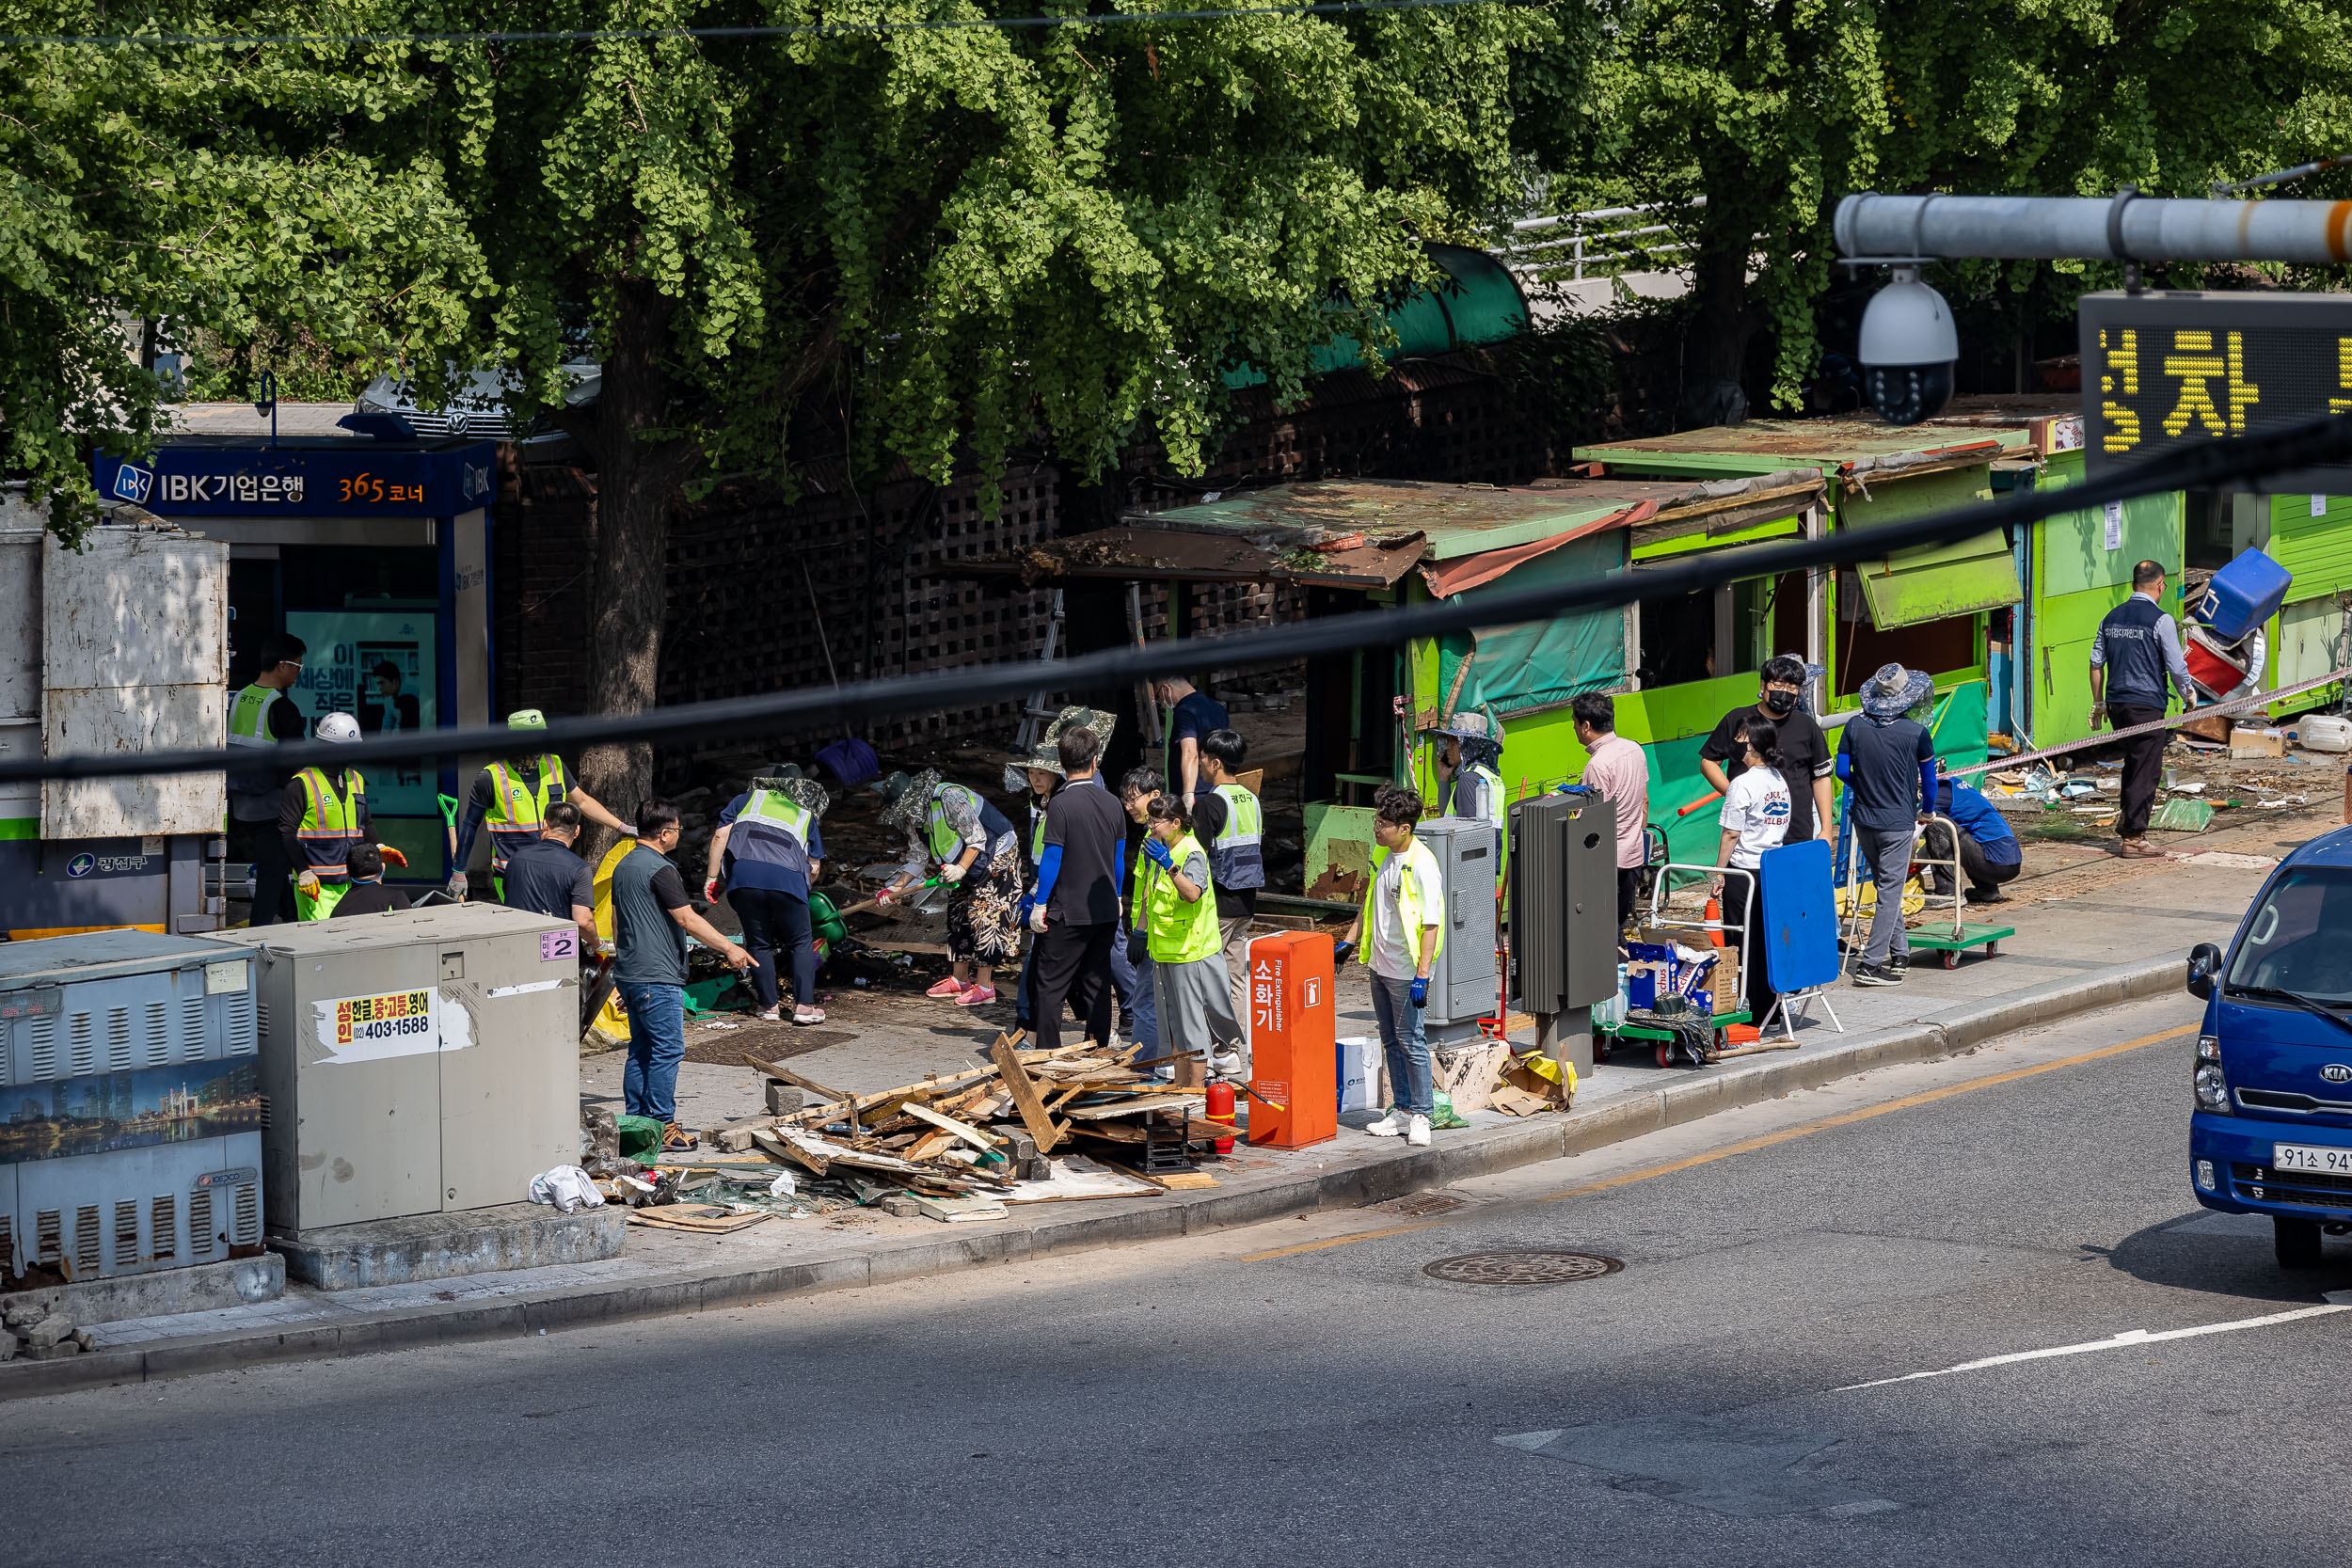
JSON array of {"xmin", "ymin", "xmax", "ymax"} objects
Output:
[{"xmin": 221, "ymin": 903, "xmax": 581, "ymax": 1232}]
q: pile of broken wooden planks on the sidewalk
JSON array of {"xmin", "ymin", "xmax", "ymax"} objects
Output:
[{"xmin": 583, "ymin": 1035, "xmax": 1235, "ymax": 1234}]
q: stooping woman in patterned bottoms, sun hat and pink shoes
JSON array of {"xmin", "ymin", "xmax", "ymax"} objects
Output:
[{"xmin": 875, "ymin": 768, "xmax": 1021, "ymax": 1006}]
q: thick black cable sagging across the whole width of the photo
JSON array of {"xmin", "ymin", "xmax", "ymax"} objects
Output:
[{"xmin": 13, "ymin": 414, "xmax": 2352, "ymax": 783}]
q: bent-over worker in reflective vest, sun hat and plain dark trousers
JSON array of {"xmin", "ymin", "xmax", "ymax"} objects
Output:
[{"xmin": 704, "ymin": 762, "xmax": 833, "ymax": 1025}]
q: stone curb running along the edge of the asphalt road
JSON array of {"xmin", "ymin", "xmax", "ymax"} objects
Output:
[{"xmin": 0, "ymin": 955, "xmax": 2183, "ymax": 1402}]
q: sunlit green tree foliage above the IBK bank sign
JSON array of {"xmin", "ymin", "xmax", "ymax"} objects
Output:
[{"xmin": 0, "ymin": 0, "xmax": 489, "ymax": 536}]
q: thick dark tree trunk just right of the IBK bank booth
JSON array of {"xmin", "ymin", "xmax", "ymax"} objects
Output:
[{"xmin": 579, "ymin": 282, "xmax": 699, "ymax": 856}]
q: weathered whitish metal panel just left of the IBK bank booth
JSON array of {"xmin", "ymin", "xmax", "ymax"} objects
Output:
[{"xmin": 40, "ymin": 527, "xmax": 229, "ymax": 839}]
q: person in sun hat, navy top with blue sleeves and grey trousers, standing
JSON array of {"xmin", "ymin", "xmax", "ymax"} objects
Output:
[{"xmin": 1844, "ymin": 665, "xmax": 1936, "ymax": 985}]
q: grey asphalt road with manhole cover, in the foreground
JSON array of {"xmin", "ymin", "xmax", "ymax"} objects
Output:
[{"xmin": 0, "ymin": 1002, "xmax": 2352, "ymax": 1568}]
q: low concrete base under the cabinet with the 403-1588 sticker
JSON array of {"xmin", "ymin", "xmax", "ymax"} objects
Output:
[{"xmin": 268, "ymin": 1204, "xmax": 628, "ymax": 1291}]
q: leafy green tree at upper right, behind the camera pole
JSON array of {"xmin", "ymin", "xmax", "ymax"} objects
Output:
[{"xmin": 1555, "ymin": 0, "xmax": 2352, "ymax": 406}]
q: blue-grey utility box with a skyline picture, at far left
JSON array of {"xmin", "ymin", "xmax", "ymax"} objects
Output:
[{"xmin": 0, "ymin": 931, "xmax": 268, "ymax": 1279}]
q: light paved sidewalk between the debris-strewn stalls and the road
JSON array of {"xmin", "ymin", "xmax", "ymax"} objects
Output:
[{"xmin": 0, "ymin": 814, "xmax": 2336, "ymax": 1399}]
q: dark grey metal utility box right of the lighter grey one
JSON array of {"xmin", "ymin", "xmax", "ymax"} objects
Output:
[{"xmin": 1510, "ymin": 795, "xmax": 1618, "ymax": 1016}]
